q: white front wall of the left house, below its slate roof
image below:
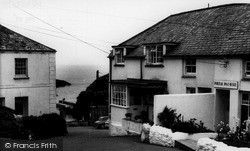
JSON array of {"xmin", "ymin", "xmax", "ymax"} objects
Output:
[{"xmin": 0, "ymin": 52, "xmax": 58, "ymax": 115}]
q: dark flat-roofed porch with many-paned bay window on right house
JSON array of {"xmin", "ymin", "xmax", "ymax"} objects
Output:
[{"xmin": 110, "ymin": 79, "xmax": 168, "ymax": 135}]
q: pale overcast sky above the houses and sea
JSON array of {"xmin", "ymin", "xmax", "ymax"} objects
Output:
[{"xmin": 0, "ymin": 0, "xmax": 250, "ymax": 72}]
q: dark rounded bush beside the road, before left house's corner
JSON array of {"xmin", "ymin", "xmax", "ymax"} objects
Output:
[{"xmin": 17, "ymin": 113, "xmax": 67, "ymax": 139}]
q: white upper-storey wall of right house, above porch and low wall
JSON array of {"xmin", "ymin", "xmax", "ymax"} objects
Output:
[{"xmin": 112, "ymin": 58, "xmax": 215, "ymax": 94}]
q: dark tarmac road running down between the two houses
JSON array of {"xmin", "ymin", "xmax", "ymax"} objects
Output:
[{"xmin": 59, "ymin": 127, "xmax": 180, "ymax": 151}]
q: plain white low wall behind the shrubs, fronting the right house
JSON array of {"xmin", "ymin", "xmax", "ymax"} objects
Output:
[{"xmin": 154, "ymin": 93, "xmax": 215, "ymax": 130}]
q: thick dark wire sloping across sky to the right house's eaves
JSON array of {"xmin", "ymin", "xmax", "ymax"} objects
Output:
[{"xmin": 14, "ymin": 5, "xmax": 109, "ymax": 54}]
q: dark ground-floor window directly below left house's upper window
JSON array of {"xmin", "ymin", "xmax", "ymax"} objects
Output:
[{"xmin": 15, "ymin": 97, "xmax": 28, "ymax": 116}]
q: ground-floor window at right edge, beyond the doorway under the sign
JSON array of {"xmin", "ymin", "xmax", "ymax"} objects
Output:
[{"xmin": 241, "ymin": 93, "xmax": 250, "ymax": 122}]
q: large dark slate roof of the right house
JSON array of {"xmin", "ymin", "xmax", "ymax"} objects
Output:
[{"xmin": 115, "ymin": 4, "xmax": 250, "ymax": 57}]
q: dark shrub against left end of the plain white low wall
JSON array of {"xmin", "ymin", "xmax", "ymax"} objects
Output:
[{"xmin": 158, "ymin": 106, "xmax": 177, "ymax": 128}]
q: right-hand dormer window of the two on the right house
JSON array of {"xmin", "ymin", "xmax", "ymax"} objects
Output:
[{"xmin": 146, "ymin": 45, "xmax": 164, "ymax": 64}]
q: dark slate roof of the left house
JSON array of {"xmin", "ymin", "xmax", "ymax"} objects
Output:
[{"xmin": 0, "ymin": 25, "xmax": 56, "ymax": 52}]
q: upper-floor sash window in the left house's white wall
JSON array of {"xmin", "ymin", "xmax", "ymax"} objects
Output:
[{"xmin": 15, "ymin": 58, "xmax": 28, "ymax": 78}]
